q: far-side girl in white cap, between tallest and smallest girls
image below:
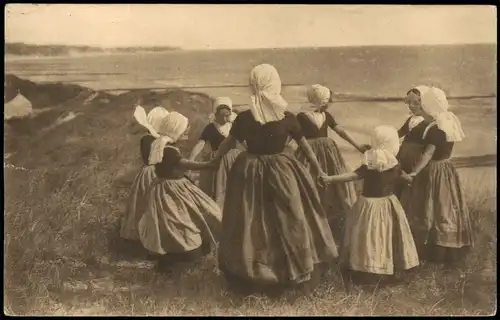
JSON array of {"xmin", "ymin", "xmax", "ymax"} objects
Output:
[{"xmin": 295, "ymin": 84, "xmax": 369, "ymax": 240}]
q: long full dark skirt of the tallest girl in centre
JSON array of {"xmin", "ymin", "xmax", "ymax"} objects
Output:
[{"xmin": 219, "ymin": 152, "xmax": 338, "ymax": 286}]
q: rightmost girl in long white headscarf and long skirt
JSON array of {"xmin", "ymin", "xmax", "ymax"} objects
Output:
[{"xmin": 403, "ymin": 87, "xmax": 473, "ymax": 267}]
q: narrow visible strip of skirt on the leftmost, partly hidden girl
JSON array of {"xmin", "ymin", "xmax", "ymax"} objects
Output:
[{"xmin": 120, "ymin": 166, "xmax": 156, "ymax": 240}]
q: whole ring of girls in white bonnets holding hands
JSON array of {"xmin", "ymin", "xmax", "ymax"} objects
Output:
[{"xmin": 121, "ymin": 64, "xmax": 473, "ymax": 292}]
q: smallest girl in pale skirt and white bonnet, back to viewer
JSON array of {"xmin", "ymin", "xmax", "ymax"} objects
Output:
[{"xmin": 322, "ymin": 126, "xmax": 419, "ymax": 282}]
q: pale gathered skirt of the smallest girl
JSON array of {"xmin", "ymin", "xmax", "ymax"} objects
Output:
[{"xmin": 341, "ymin": 195, "xmax": 419, "ymax": 275}]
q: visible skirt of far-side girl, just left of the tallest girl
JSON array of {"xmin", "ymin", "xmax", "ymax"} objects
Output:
[{"xmin": 199, "ymin": 149, "xmax": 242, "ymax": 210}]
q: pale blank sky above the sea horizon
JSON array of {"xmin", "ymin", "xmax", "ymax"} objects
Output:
[{"xmin": 5, "ymin": 4, "xmax": 497, "ymax": 50}]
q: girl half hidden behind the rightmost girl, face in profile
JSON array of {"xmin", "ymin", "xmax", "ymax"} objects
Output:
[{"xmin": 396, "ymin": 86, "xmax": 429, "ymax": 200}]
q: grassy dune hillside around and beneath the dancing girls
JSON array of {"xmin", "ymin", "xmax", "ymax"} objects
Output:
[{"xmin": 4, "ymin": 81, "xmax": 496, "ymax": 315}]
